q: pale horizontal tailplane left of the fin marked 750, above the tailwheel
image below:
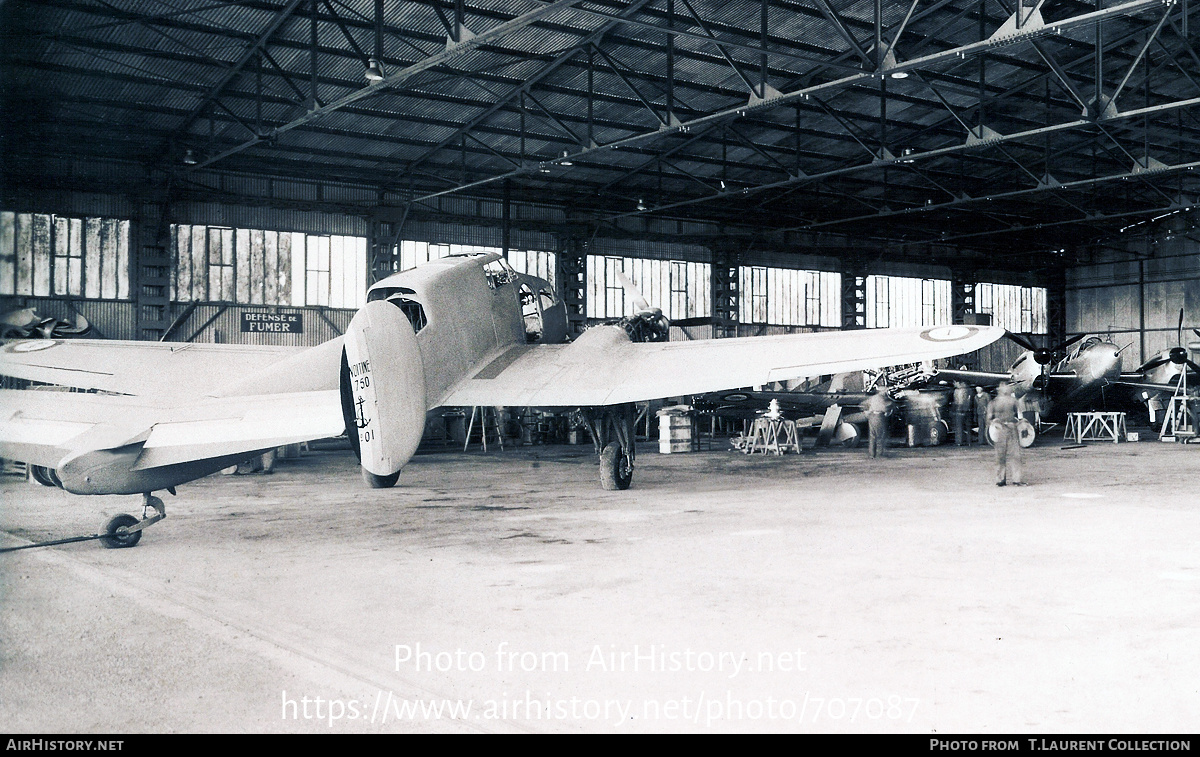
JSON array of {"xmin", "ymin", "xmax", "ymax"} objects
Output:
[{"xmin": 0, "ymin": 390, "xmax": 346, "ymax": 470}]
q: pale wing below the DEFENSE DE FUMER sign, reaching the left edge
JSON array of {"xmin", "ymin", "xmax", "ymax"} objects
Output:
[{"xmin": 0, "ymin": 340, "xmax": 341, "ymax": 401}]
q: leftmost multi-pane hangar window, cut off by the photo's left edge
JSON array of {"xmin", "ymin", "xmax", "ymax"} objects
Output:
[{"xmin": 0, "ymin": 211, "xmax": 130, "ymax": 300}]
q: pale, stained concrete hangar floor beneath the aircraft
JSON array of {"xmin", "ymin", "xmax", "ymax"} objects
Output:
[{"xmin": 0, "ymin": 440, "xmax": 1200, "ymax": 733}]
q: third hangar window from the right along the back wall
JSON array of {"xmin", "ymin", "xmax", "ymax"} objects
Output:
[{"xmin": 738, "ymin": 265, "xmax": 841, "ymax": 326}]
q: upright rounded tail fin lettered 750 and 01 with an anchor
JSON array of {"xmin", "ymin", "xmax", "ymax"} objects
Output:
[{"xmin": 341, "ymin": 300, "xmax": 426, "ymax": 488}]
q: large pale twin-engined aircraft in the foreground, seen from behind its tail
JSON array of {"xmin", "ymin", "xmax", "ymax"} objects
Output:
[{"xmin": 0, "ymin": 253, "xmax": 1004, "ymax": 546}]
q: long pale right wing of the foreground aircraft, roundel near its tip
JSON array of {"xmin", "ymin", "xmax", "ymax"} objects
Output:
[{"xmin": 437, "ymin": 326, "xmax": 1004, "ymax": 407}]
